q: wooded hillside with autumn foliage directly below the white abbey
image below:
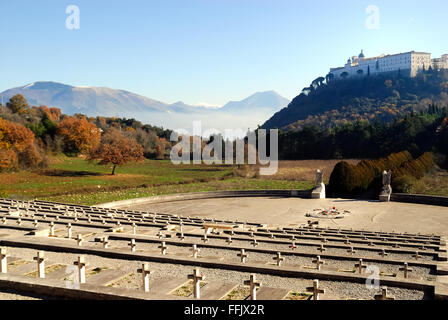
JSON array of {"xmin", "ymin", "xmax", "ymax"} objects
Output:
[{"xmin": 263, "ymin": 69, "xmax": 448, "ymax": 130}]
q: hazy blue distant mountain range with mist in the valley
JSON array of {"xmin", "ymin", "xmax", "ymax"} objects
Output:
[{"xmin": 0, "ymin": 81, "xmax": 289, "ymax": 130}]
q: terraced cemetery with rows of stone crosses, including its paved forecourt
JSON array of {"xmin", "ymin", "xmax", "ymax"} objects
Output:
[{"xmin": 0, "ymin": 171, "xmax": 448, "ymax": 300}]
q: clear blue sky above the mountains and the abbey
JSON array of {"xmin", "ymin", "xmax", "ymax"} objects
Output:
[{"xmin": 0, "ymin": 0, "xmax": 448, "ymax": 105}]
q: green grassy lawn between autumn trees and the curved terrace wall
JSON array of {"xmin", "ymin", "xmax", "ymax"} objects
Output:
[{"xmin": 0, "ymin": 156, "xmax": 314, "ymax": 205}]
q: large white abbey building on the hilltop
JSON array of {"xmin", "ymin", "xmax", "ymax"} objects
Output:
[{"xmin": 327, "ymin": 50, "xmax": 448, "ymax": 80}]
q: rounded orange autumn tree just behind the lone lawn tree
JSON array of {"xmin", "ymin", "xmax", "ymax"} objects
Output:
[{"xmin": 57, "ymin": 117, "xmax": 101, "ymax": 154}]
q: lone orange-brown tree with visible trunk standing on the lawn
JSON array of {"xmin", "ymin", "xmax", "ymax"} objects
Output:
[{"xmin": 87, "ymin": 129, "xmax": 145, "ymax": 175}]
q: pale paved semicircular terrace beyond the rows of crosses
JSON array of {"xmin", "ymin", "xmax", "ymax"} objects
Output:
[{"xmin": 112, "ymin": 197, "xmax": 448, "ymax": 235}]
